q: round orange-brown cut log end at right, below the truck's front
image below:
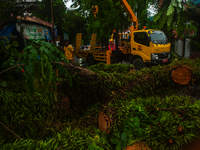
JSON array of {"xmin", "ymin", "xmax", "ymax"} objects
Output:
[{"xmin": 171, "ymin": 65, "xmax": 192, "ymax": 85}]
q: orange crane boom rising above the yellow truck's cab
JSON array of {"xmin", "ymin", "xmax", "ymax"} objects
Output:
[{"xmin": 119, "ymin": 0, "xmax": 138, "ymax": 33}]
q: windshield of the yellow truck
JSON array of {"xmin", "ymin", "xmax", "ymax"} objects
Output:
[{"xmin": 149, "ymin": 31, "xmax": 169, "ymax": 44}]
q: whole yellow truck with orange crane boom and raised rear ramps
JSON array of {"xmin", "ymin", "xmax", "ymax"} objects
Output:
[{"xmin": 75, "ymin": 0, "xmax": 171, "ymax": 69}]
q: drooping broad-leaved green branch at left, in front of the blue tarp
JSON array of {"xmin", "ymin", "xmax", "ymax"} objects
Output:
[{"xmin": 2, "ymin": 41, "xmax": 71, "ymax": 98}]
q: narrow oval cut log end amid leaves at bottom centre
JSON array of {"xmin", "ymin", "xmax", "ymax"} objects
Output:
[{"xmin": 98, "ymin": 111, "xmax": 112, "ymax": 133}]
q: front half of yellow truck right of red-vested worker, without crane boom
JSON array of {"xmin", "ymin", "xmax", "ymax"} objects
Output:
[{"xmin": 116, "ymin": 29, "xmax": 171, "ymax": 69}]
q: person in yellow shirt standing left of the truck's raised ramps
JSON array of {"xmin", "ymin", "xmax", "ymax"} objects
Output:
[{"xmin": 64, "ymin": 40, "xmax": 74, "ymax": 63}]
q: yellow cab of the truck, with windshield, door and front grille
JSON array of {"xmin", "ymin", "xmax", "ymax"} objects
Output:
[{"xmin": 131, "ymin": 29, "xmax": 171, "ymax": 64}]
